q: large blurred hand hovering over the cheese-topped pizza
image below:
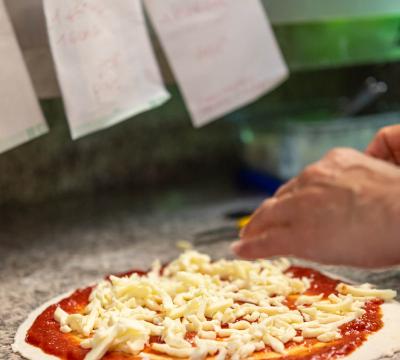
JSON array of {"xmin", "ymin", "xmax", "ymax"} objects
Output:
[{"xmin": 232, "ymin": 149, "xmax": 400, "ymax": 266}]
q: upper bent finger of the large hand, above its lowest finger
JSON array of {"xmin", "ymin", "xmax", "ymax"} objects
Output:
[{"xmin": 240, "ymin": 195, "xmax": 293, "ymax": 240}]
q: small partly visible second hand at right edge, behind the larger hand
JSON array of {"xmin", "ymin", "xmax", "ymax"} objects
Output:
[{"xmin": 365, "ymin": 125, "xmax": 400, "ymax": 165}]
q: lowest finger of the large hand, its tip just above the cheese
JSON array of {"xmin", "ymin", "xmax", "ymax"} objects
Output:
[{"xmin": 231, "ymin": 228, "xmax": 304, "ymax": 259}]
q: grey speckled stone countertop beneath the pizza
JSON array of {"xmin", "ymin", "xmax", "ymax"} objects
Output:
[{"xmin": 0, "ymin": 193, "xmax": 400, "ymax": 360}]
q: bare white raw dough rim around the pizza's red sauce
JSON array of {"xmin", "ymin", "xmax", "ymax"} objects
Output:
[{"xmin": 12, "ymin": 271, "xmax": 400, "ymax": 360}]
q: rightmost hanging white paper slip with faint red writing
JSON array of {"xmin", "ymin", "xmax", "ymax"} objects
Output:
[{"xmin": 145, "ymin": 0, "xmax": 288, "ymax": 126}]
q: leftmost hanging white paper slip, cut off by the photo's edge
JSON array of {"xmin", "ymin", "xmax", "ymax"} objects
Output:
[{"xmin": 0, "ymin": 0, "xmax": 48, "ymax": 152}]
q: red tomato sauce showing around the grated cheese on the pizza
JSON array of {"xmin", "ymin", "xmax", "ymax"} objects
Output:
[{"xmin": 26, "ymin": 266, "xmax": 383, "ymax": 360}]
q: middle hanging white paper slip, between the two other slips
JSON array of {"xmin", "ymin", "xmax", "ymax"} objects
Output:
[{"xmin": 44, "ymin": 0, "xmax": 169, "ymax": 139}]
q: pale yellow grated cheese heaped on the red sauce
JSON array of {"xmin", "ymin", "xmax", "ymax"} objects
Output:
[{"xmin": 54, "ymin": 251, "xmax": 396, "ymax": 360}]
